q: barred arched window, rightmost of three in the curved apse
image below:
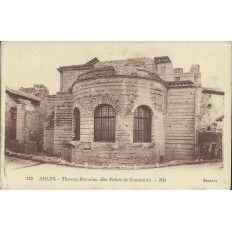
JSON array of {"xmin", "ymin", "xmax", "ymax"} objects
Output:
[{"xmin": 134, "ymin": 106, "xmax": 151, "ymax": 142}]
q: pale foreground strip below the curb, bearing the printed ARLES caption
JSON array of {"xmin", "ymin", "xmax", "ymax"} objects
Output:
[{"xmin": 2, "ymin": 157, "xmax": 226, "ymax": 189}]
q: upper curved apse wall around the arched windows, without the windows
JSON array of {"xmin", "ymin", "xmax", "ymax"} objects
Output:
[{"xmin": 73, "ymin": 76, "xmax": 166, "ymax": 143}]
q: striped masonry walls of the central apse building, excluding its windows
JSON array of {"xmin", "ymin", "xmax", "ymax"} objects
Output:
[{"xmin": 52, "ymin": 57, "xmax": 214, "ymax": 165}]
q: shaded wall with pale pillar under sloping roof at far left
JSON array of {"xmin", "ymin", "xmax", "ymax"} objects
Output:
[{"xmin": 5, "ymin": 92, "xmax": 43, "ymax": 155}]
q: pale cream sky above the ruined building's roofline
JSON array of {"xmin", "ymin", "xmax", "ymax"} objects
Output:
[{"xmin": 1, "ymin": 42, "xmax": 231, "ymax": 94}]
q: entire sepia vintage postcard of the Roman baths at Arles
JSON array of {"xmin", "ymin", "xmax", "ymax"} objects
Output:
[{"xmin": 1, "ymin": 42, "xmax": 231, "ymax": 189}]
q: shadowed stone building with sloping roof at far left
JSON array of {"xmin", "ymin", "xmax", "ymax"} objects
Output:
[{"xmin": 5, "ymin": 85, "xmax": 48, "ymax": 154}]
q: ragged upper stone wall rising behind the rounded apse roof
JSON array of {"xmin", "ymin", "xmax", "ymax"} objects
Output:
[{"xmin": 58, "ymin": 57, "xmax": 201, "ymax": 92}]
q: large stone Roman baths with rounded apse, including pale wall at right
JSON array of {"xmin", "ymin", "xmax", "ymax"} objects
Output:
[{"xmin": 43, "ymin": 56, "xmax": 224, "ymax": 165}]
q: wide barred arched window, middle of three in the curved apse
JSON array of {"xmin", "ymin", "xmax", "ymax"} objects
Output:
[{"xmin": 94, "ymin": 105, "xmax": 115, "ymax": 142}]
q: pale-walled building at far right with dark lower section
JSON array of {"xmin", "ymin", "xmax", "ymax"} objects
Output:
[{"xmin": 196, "ymin": 88, "xmax": 224, "ymax": 158}]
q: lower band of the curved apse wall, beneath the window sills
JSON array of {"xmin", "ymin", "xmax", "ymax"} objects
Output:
[{"xmin": 61, "ymin": 141, "xmax": 175, "ymax": 166}]
